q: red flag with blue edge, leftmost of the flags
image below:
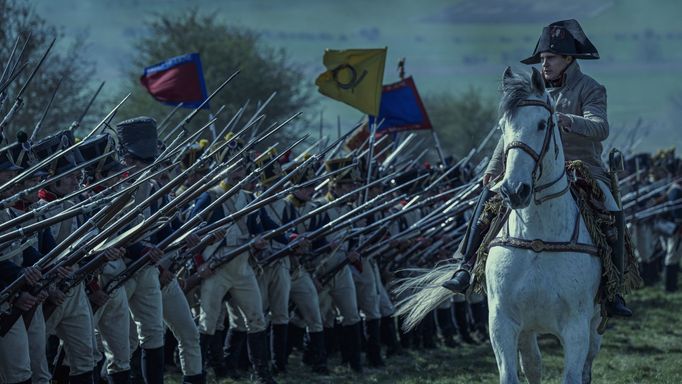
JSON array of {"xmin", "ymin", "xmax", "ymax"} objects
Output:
[{"xmin": 140, "ymin": 53, "xmax": 208, "ymax": 108}]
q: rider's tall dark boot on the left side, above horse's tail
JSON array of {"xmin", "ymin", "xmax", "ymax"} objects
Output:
[{"xmin": 443, "ymin": 187, "xmax": 495, "ymax": 293}]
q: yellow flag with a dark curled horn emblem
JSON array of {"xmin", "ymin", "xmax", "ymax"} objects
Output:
[{"xmin": 315, "ymin": 48, "xmax": 386, "ymax": 116}]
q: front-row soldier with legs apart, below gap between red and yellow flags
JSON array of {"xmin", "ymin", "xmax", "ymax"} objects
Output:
[{"xmin": 190, "ymin": 135, "xmax": 274, "ymax": 383}]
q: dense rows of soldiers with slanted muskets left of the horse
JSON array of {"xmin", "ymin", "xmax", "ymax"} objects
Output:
[{"xmin": 0, "ymin": 110, "xmax": 487, "ymax": 384}]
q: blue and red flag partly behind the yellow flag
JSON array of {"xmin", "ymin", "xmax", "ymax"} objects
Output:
[{"xmin": 369, "ymin": 76, "xmax": 432, "ymax": 134}]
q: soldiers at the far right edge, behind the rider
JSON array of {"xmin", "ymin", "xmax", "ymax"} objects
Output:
[{"xmin": 623, "ymin": 148, "xmax": 682, "ymax": 292}]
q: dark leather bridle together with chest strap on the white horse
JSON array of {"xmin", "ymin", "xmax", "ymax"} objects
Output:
[{"xmin": 488, "ymin": 99, "xmax": 598, "ymax": 256}]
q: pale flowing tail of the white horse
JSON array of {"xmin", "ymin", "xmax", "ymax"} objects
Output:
[{"xmin": 393, "ymin": 264, "xmax": 455, "ymax": 331}]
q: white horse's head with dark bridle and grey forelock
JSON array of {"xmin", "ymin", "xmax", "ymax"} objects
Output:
[{"xmin": 499, "ymin": 67, "xmax": 563, "ymax": 209}]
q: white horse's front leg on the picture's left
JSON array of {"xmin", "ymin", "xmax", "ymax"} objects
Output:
[{"xmin": 489, "ymin": 301, "xmax": 520, "ymax": 384}]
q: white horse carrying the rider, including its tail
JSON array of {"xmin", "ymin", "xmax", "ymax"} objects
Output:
[{"xmin": 398, "ymin": 68, "xmax": 601, "ymax": 384}]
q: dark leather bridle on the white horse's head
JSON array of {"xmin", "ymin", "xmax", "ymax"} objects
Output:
[{"xmin": 504, "ymin": 99, "xmax": 568, "ymax": 204}]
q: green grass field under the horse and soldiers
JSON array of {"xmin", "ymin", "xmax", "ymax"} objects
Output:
[{"xmin": 167, "ymin": 286, "xmax": 682, "ymax": 384}]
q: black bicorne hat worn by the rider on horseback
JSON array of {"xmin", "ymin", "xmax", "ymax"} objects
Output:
[{"xmin": 521, "ymin": 19, "xmax": 599, "ymax": 64}]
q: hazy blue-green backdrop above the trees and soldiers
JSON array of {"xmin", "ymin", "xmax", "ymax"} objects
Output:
[{"xmin": 33, "ymin": 0, "xmax": 682, "ymax": 153}]
